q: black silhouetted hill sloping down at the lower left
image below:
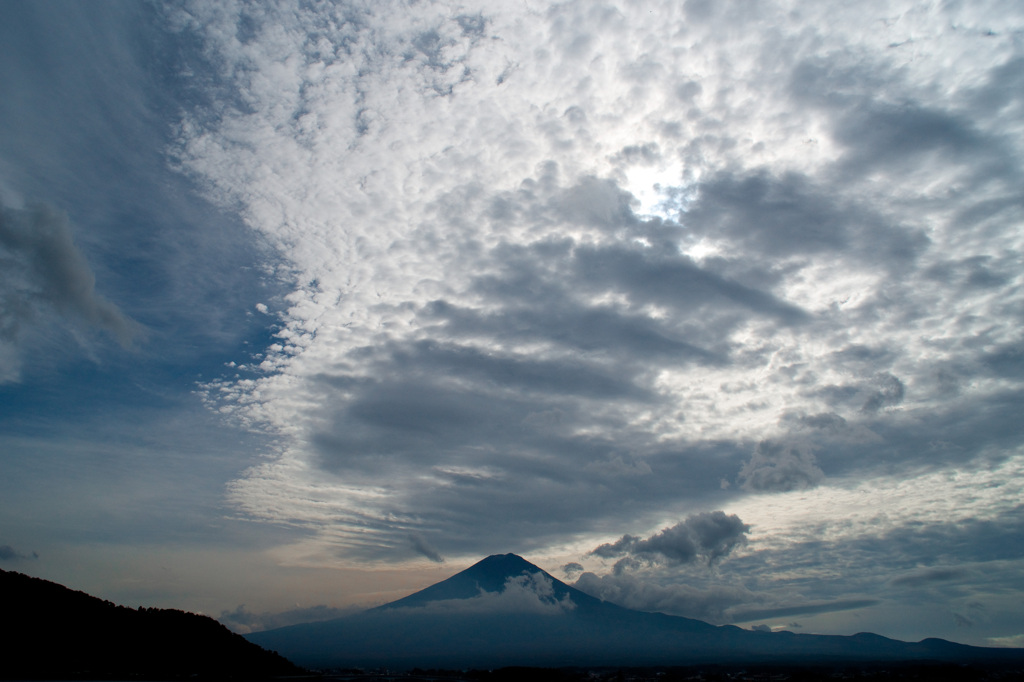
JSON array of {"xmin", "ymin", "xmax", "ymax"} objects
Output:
[{"xmin": 0, "ymin": 570, "xmax": 303, "ymax": 680}]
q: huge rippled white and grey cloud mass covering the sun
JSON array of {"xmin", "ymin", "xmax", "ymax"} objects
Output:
[{"xmin": 168, "ymin": 2, "xmax": 1024, "ymax": 573}]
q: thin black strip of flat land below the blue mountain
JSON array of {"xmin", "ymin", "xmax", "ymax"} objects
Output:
[{"xmin": 321, "ymin": 663, "xmax": 1024, "ymax": 682}]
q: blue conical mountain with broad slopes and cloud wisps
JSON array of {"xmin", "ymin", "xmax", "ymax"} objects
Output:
[{"xmin": 247, "ymin": 554, "xmax": 1024, "ymax": 669}]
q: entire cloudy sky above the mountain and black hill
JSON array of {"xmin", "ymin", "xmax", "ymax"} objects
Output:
[{"xmin": 0, "ymin": 0, "xmax": 1024, "ymax": 646}]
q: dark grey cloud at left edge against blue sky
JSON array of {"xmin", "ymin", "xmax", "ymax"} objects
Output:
[{"xmin": 0, "ymin": 200, "xmax": 139, "ymax": 345}]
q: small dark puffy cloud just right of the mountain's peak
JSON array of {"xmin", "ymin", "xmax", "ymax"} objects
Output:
[{"xmin": 590, "ymin": 511, "xmax": 751, "ymax": 564}]
